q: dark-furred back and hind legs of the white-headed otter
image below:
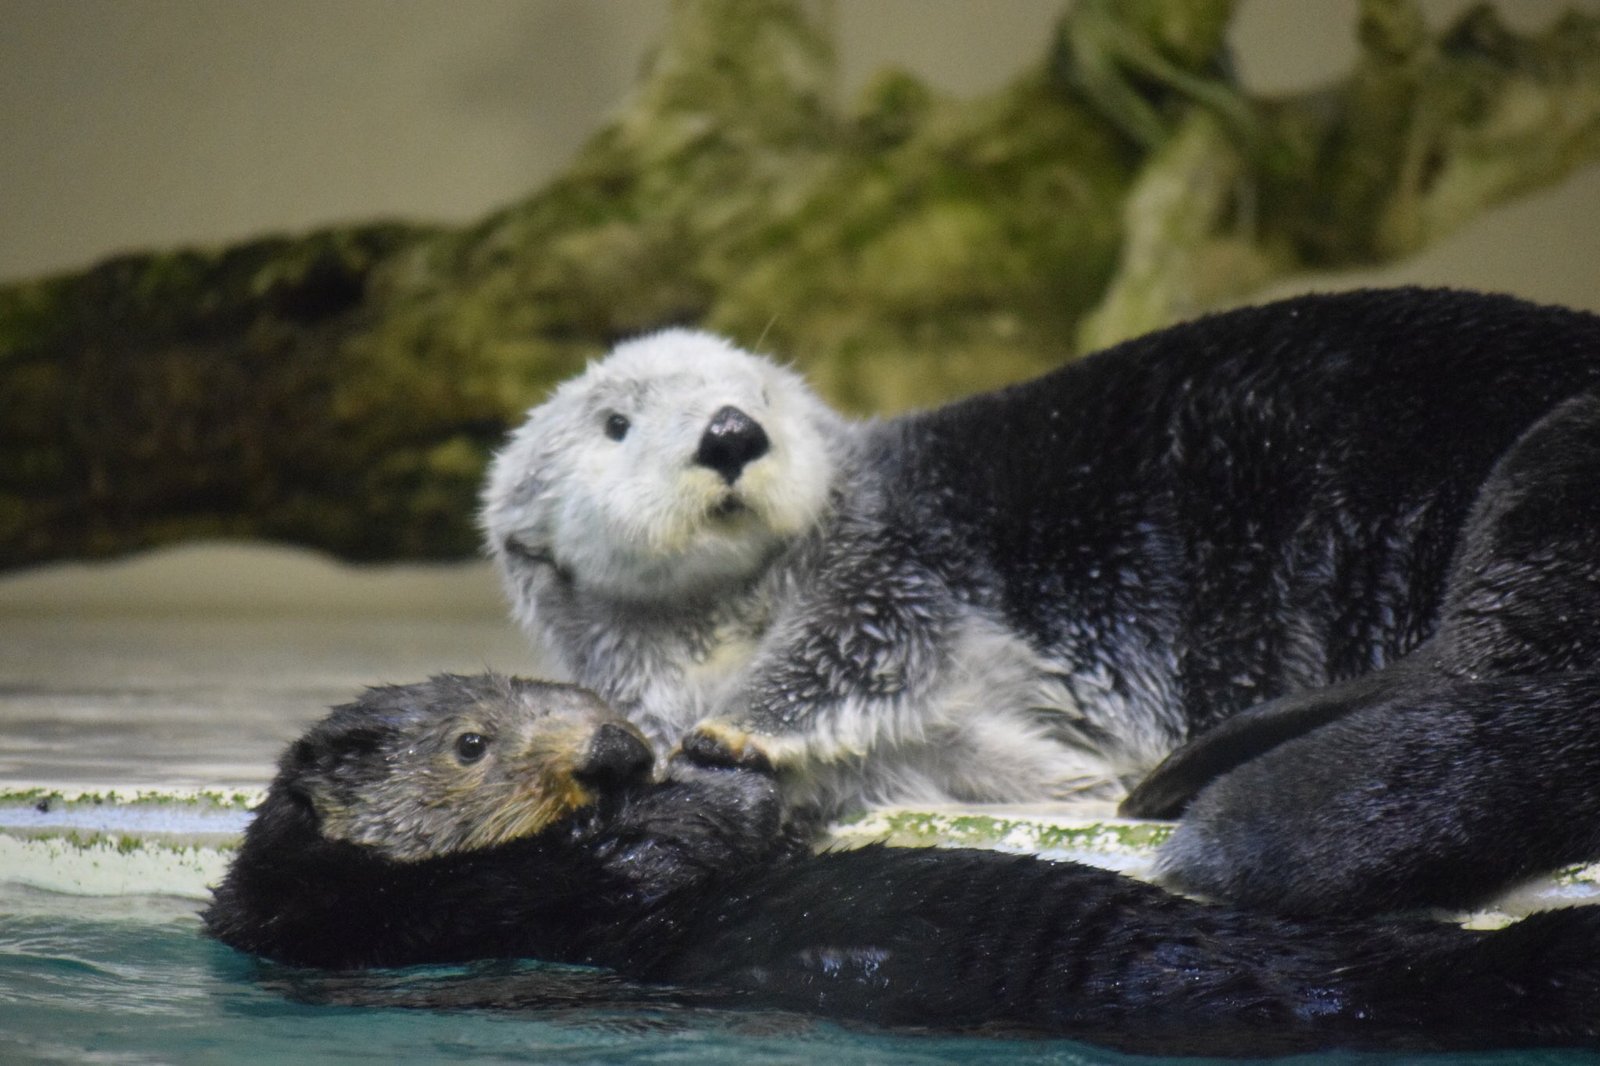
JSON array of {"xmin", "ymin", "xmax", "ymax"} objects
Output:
[{"xmin": 819, "ymin": 290, "xmax": 1600, "ymax": 912}]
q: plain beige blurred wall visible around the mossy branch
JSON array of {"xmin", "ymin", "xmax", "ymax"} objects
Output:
[{"xmin": 0, "ymin": 0, "xmax": 1600, "ymax": 611}]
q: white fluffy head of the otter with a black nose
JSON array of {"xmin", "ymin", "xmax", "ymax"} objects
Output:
[{"xmin": 483, "ymin": 330, "xmax": 840, "ymax": 601}]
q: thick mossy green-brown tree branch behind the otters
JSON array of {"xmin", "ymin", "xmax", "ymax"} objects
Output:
[{"xmin": 0, "ymin": 0, "xmax": 1600, "ymax": 567}]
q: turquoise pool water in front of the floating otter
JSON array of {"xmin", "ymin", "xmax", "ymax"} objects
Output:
[{"xmin": 0, "ymin": 888, "xmax": 1600, "ymax": 1066}]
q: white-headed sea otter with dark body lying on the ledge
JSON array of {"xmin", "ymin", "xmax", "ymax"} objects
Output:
[{"xmin": 483, "ymin": 290, "xmax": 1600, "ymax": 912}]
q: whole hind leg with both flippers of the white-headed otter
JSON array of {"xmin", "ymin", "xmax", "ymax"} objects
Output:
[{"xmin": 1138, "ymin": 395, "xmax": 1600, "ymax": 911}]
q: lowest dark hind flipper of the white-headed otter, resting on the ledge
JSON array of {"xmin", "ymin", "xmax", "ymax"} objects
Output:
[{"xmin": 1160, "ymin": 671, "xmax": 1600, "ymax": 914}]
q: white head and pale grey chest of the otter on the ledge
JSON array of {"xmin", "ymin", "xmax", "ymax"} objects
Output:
[{"xmin": 485, "ymin": 331, "xmax": 1152, "ymax": 807}]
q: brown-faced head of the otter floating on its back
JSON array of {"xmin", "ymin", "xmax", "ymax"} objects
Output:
[{"xmin": 275, "ymin": 675, "xmax": 653, "ymax": 861}]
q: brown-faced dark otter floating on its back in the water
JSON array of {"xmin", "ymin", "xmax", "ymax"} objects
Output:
[{"xmin": 205, "ymin": 677, "xmax": 1600, "ymax": 1055}]
